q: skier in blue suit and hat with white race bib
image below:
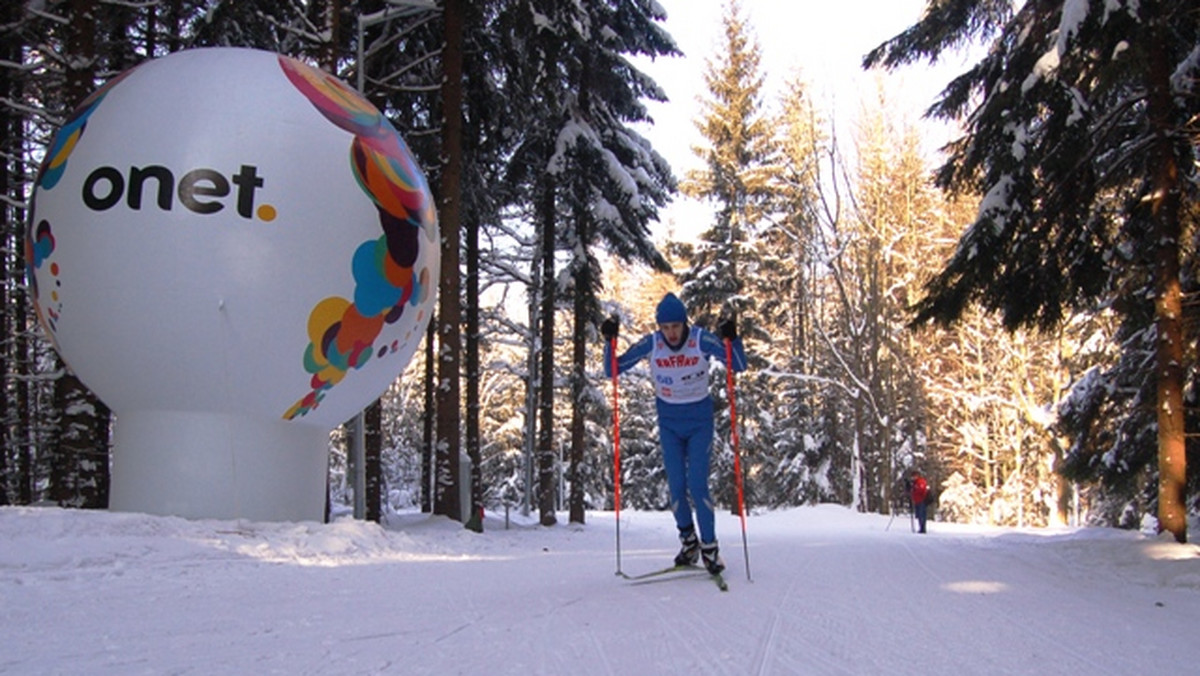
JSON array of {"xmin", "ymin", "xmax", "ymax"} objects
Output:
[{"xmin": 600, "ymin": 293, "xmax": 746, "ymax": 575}]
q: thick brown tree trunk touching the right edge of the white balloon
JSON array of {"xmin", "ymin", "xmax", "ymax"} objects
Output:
[{"xmin": 433, "ymin": 0, "xmax": 464, "ymax": 521}]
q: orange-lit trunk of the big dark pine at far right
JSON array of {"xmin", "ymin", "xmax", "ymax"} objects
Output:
[{"xmin": 1146, "ymin": 23, "xmax": 1188, "ymax": 543}]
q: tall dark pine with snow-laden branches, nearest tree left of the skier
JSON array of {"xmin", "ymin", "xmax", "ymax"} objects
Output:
[{"xmin": 551, "ymin": 0, "xmax": 674, "ymax": 522}]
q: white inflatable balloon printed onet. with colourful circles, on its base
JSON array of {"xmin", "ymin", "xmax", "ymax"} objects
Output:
[{"xmin": 25, "ymin": 48, "xmax": 438, "ymax": 521}]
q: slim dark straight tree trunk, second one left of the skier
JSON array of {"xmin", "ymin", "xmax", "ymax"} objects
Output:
[{"xmin": 538, "ymin": 175, "xmax": 558, "ymax": 526}]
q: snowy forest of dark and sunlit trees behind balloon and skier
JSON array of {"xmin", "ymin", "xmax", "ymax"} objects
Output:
[{"xmin": 0, "ymin": 0, "xmax": 1200, "ymax": 537}]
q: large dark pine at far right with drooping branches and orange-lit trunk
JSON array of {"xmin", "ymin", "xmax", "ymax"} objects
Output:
[{"xmin": 865, "ymin": 0, "xmax": 1200, "ymax": 542}]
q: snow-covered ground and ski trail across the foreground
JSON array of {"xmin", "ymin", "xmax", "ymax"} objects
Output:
[{"xmin": 0, "ymin": 505, "xmax": 1200, "ymax": 676}]
